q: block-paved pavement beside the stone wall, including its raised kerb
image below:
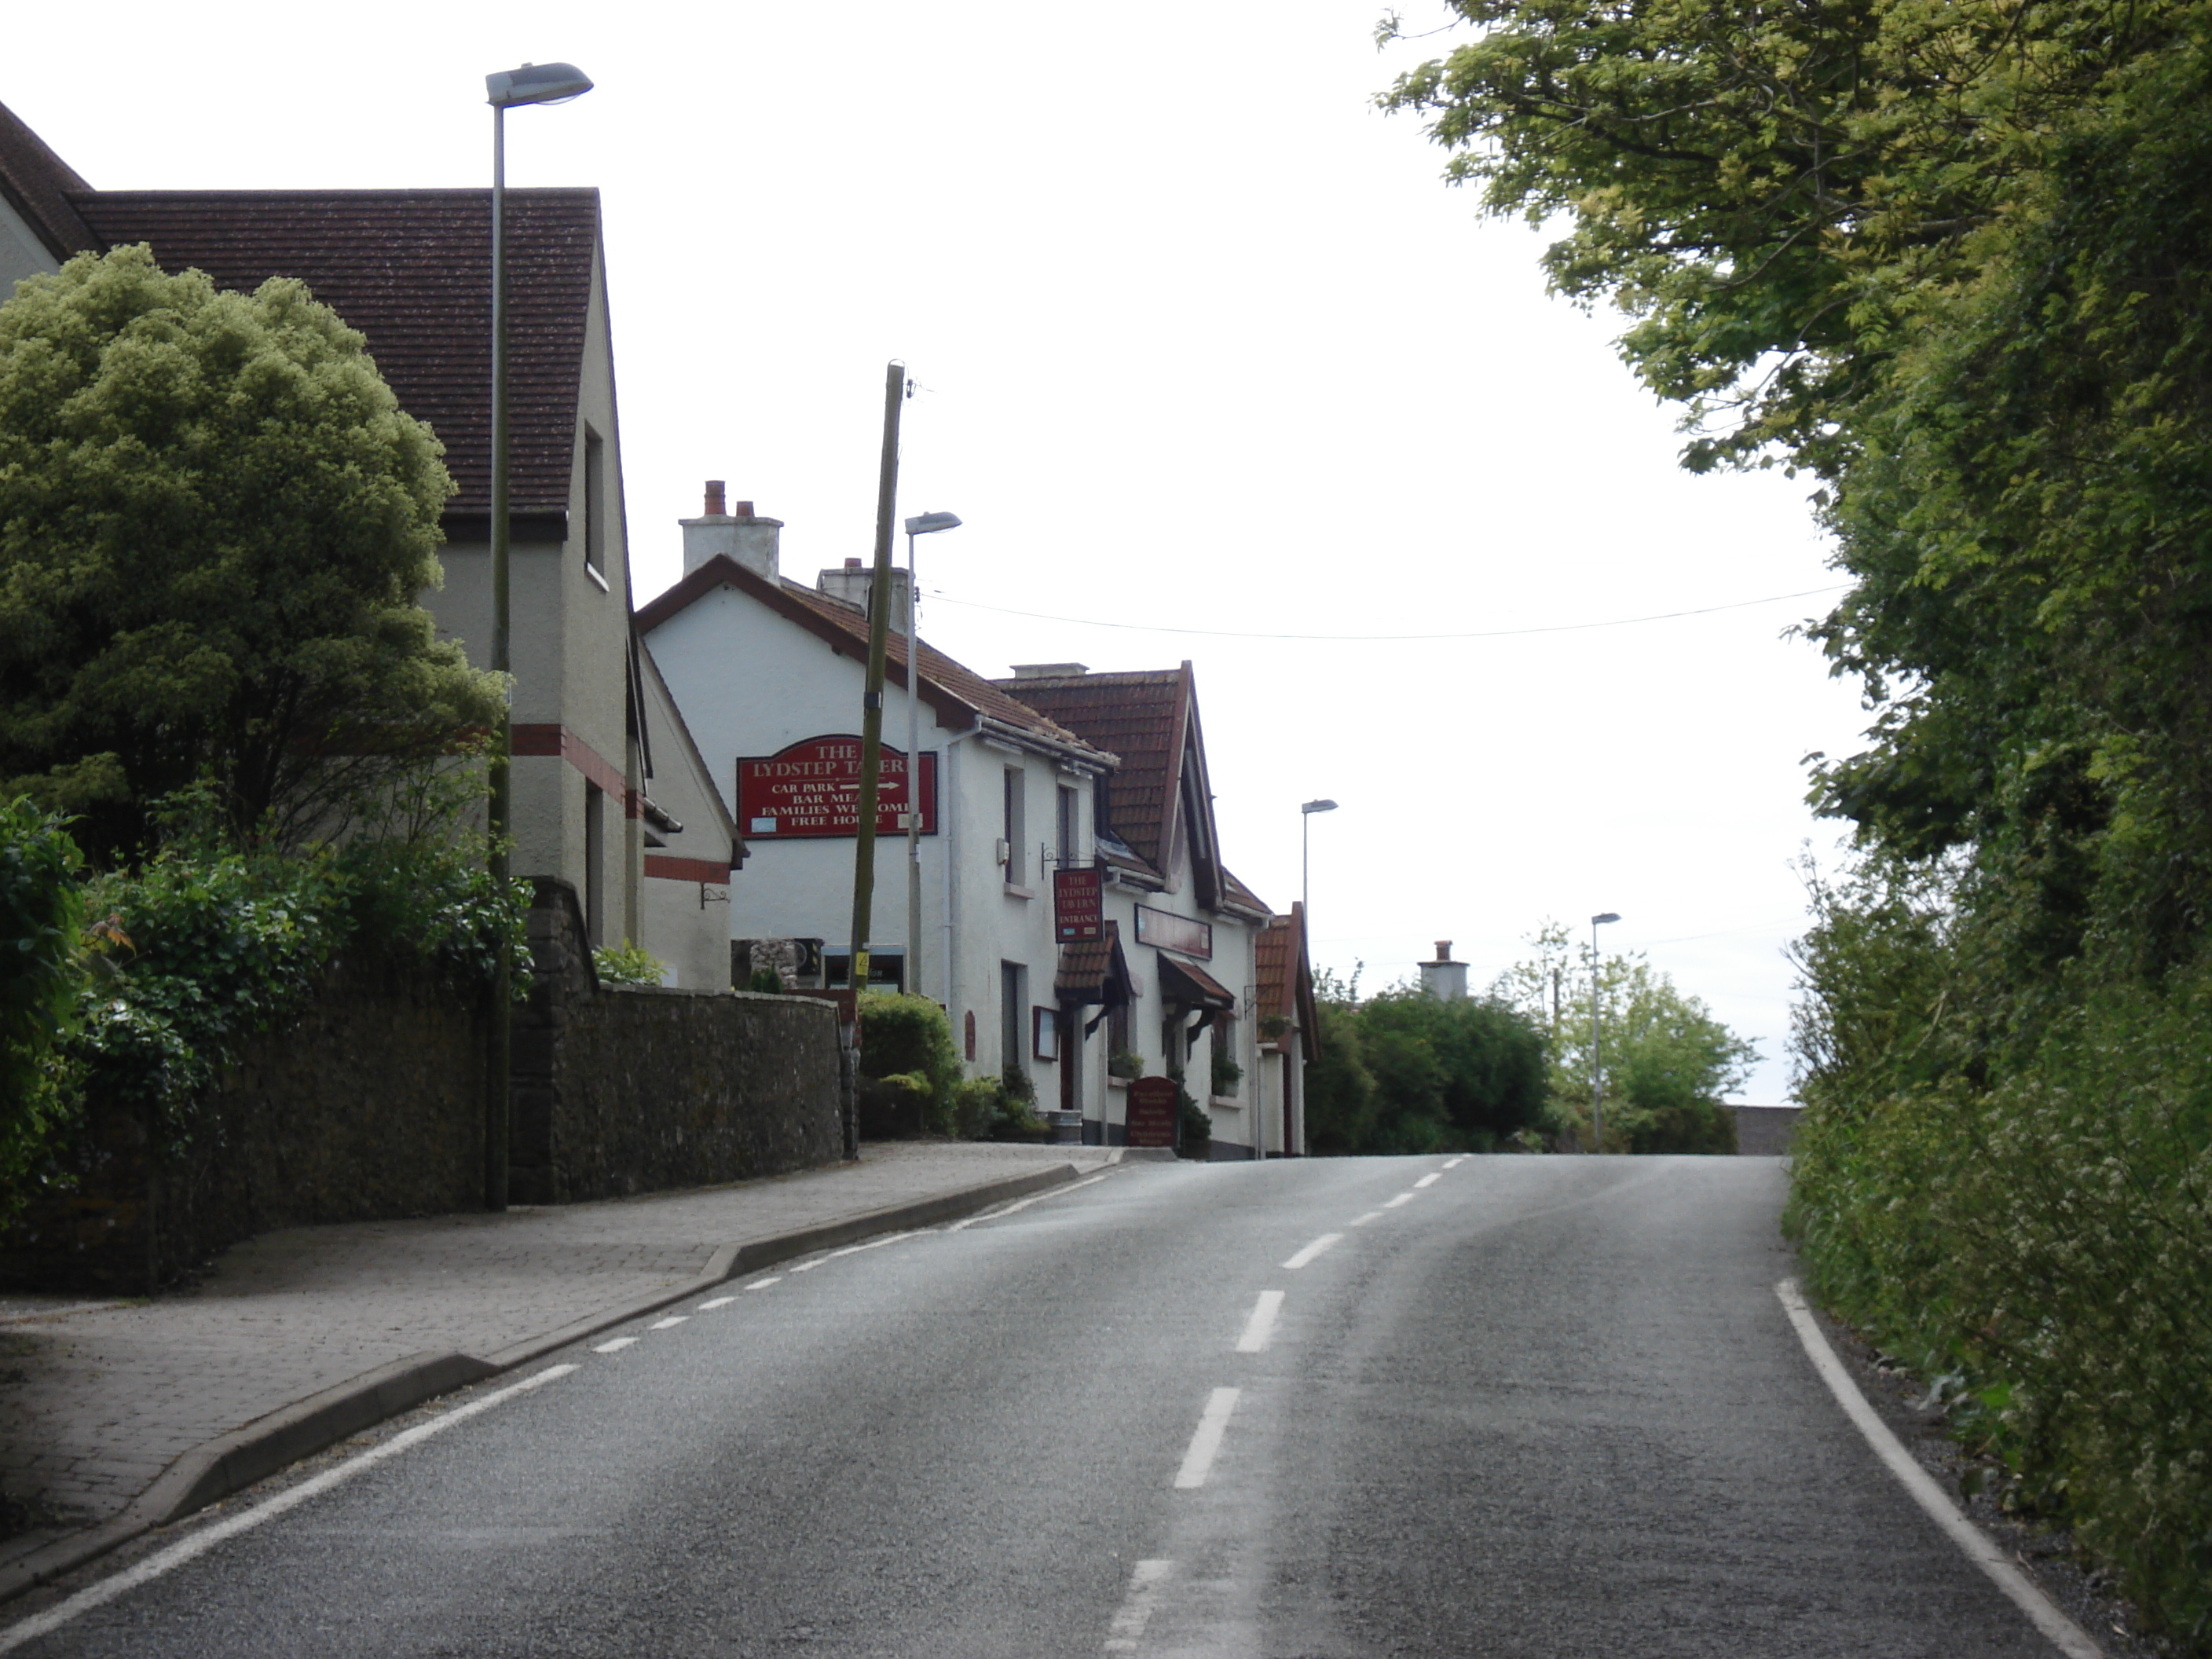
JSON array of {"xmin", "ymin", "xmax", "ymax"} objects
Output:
[{"xmin": 0, "ymin": 1141, "xmax": 1119, "ymax": 1599}]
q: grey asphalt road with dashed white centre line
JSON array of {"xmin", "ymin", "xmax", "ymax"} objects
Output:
[{"xmin": 0, "ymin": 1157, "xmax": 2049, "ymax": 1659}]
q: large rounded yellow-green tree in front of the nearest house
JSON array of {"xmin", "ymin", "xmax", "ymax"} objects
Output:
[{"xmin": 0, "ymin": 247, "xmax": 504, "ymax": 856}]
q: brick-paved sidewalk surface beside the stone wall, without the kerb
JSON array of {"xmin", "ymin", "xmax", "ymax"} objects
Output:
[{"xmin": 0, "ymin": 1144, "xmax": 1115, "ymax": 1559}]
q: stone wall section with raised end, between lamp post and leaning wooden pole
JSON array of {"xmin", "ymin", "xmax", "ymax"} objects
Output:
[{"xmin": 509, "ymin": 881, "xmax": 843, "ymax": 1203}]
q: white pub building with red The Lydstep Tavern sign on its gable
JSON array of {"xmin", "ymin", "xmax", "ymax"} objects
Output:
[{"xmin": 637, "ymin": 482, "xmax": 1314, "ymax": 1159}]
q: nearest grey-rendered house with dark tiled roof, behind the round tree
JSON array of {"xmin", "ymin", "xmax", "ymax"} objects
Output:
[{"xmin": 0, "ymin": 108, "xmax": 745, "ymax": 989}]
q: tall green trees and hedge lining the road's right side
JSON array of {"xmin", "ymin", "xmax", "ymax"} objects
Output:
[{"xmin": 1382, "ymin": 0, "xmax": 2212, "ymax": 1654}]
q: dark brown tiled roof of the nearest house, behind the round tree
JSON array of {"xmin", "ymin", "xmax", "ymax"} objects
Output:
[{"xmin": 73, "ymin": 185, "xmax": 599, "ymax": 515}]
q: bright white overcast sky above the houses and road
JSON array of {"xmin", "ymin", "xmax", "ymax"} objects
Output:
[{"xmin": 0, "ymin": 0, "xmax": 1865, "ymax": 1119}]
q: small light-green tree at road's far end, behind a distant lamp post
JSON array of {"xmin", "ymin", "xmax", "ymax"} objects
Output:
[{"xmin": 1491, "ymin": 922, "xmax": 1759, "ymax": 1152}]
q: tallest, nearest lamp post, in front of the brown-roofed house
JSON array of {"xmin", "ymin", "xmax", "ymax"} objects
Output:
[{"xmin": 485, "ymin": 64, "xmax": 591, "ymax": 1210}]
